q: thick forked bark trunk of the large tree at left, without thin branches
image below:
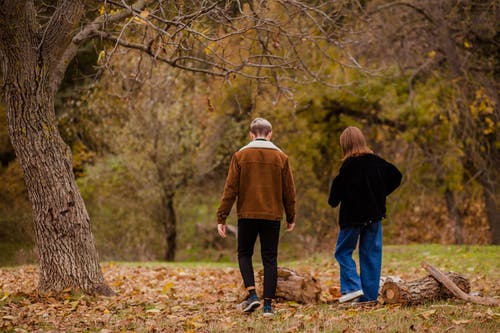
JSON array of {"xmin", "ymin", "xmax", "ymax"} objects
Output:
[{"xmin": 0, "ymin": 1, "xmax": 113, "ymax": 295}]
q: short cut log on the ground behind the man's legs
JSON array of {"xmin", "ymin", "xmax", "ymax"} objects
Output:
[{"xmin": 240, "ymin": 267, "xmax": 321, "ymax": 304}]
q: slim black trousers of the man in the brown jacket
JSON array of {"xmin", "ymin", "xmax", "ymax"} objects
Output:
[{"xmin": 238, "ymin": 219, "xmax": 281, "ymax": 298}]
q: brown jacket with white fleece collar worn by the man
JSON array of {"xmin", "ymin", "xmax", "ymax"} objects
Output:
[{"xmin": 217, "ymin": 139, "xmax": 295, "ymax": 224}]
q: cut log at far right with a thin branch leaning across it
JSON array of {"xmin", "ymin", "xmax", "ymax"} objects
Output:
[{"xmin": 380, "ymin": 272, "xmax": 470, "ymax": 305}]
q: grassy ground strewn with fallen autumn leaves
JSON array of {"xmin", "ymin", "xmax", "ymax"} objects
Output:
[{"xmin": 0, "ymin": 245, "xmax": 500, "ymax": 333}]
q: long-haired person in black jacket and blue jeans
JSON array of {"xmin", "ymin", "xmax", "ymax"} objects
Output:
[{"xmin": 328, "ymin": 127, "xmax": 402, "ymax": 303}]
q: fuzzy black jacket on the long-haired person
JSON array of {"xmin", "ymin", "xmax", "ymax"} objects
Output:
[{"xmin": 328, "ymin": 154, "xmax": 402, "ymax": 228}]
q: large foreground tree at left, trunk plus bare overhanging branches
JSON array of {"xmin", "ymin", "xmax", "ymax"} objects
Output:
[{"xmin": 0, "ymin": 0, "xmax": 356, "ymax": 295}]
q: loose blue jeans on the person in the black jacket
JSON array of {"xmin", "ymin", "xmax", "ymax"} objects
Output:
[{"xmin": 335, "ymin": 221, "xmax": 382, "ymax": 302}]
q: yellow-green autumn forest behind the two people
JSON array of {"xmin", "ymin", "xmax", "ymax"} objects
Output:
[{"xmin": 0, "ymin": 1, "xmax": 500, "ymax": 265}]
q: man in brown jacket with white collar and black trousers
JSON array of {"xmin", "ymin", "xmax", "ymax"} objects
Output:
[{"xmin": 217, "ymin": 118, "xmax": 295, "ymax": 316}]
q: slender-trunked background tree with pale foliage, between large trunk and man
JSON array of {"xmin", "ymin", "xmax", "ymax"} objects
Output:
[{"xmin": 88, "ymin": 52, "xmax": 207, "ymax": 261}]
